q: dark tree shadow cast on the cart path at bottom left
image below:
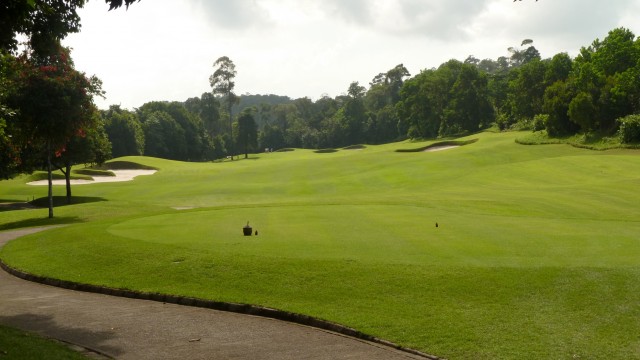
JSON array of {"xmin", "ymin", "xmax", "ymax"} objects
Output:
[{"xmin": 0, "ymin": 313, "xmax": 123, "ymax": 358}]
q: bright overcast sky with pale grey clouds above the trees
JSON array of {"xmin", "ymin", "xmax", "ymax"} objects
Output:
[{"xmin": 64, "ymin": 0, "xmax": 640, "ymax": 109}]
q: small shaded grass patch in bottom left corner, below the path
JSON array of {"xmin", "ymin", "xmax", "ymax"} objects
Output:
[{"xmin": 0, "ymin": 325, "xmax": 87, "ymax": 360}]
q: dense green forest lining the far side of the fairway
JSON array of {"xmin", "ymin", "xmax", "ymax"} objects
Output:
[{"xmin": 97, "ymin": 28, "xmax": 640, "ymax": 161}]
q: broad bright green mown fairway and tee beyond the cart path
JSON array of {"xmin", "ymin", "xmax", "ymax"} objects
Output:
[{"xmin": 0, "ymin": 133, "xmax": 640, "ymax": 359}]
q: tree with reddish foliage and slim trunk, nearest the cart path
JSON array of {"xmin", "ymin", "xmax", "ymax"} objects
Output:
[{"xmin": 9, "ymin": 45, "xmax": 102, "ymax": 218}]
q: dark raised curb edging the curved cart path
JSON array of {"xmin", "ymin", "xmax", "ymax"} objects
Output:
[{"xmin": 0, "ymin": 260, "xmax": 440, "ymax": 360}]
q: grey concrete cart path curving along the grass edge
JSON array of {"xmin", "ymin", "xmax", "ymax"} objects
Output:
[{"xmin": 0, "ymin": 228, "xmax": 424, "ymax": 360}]
